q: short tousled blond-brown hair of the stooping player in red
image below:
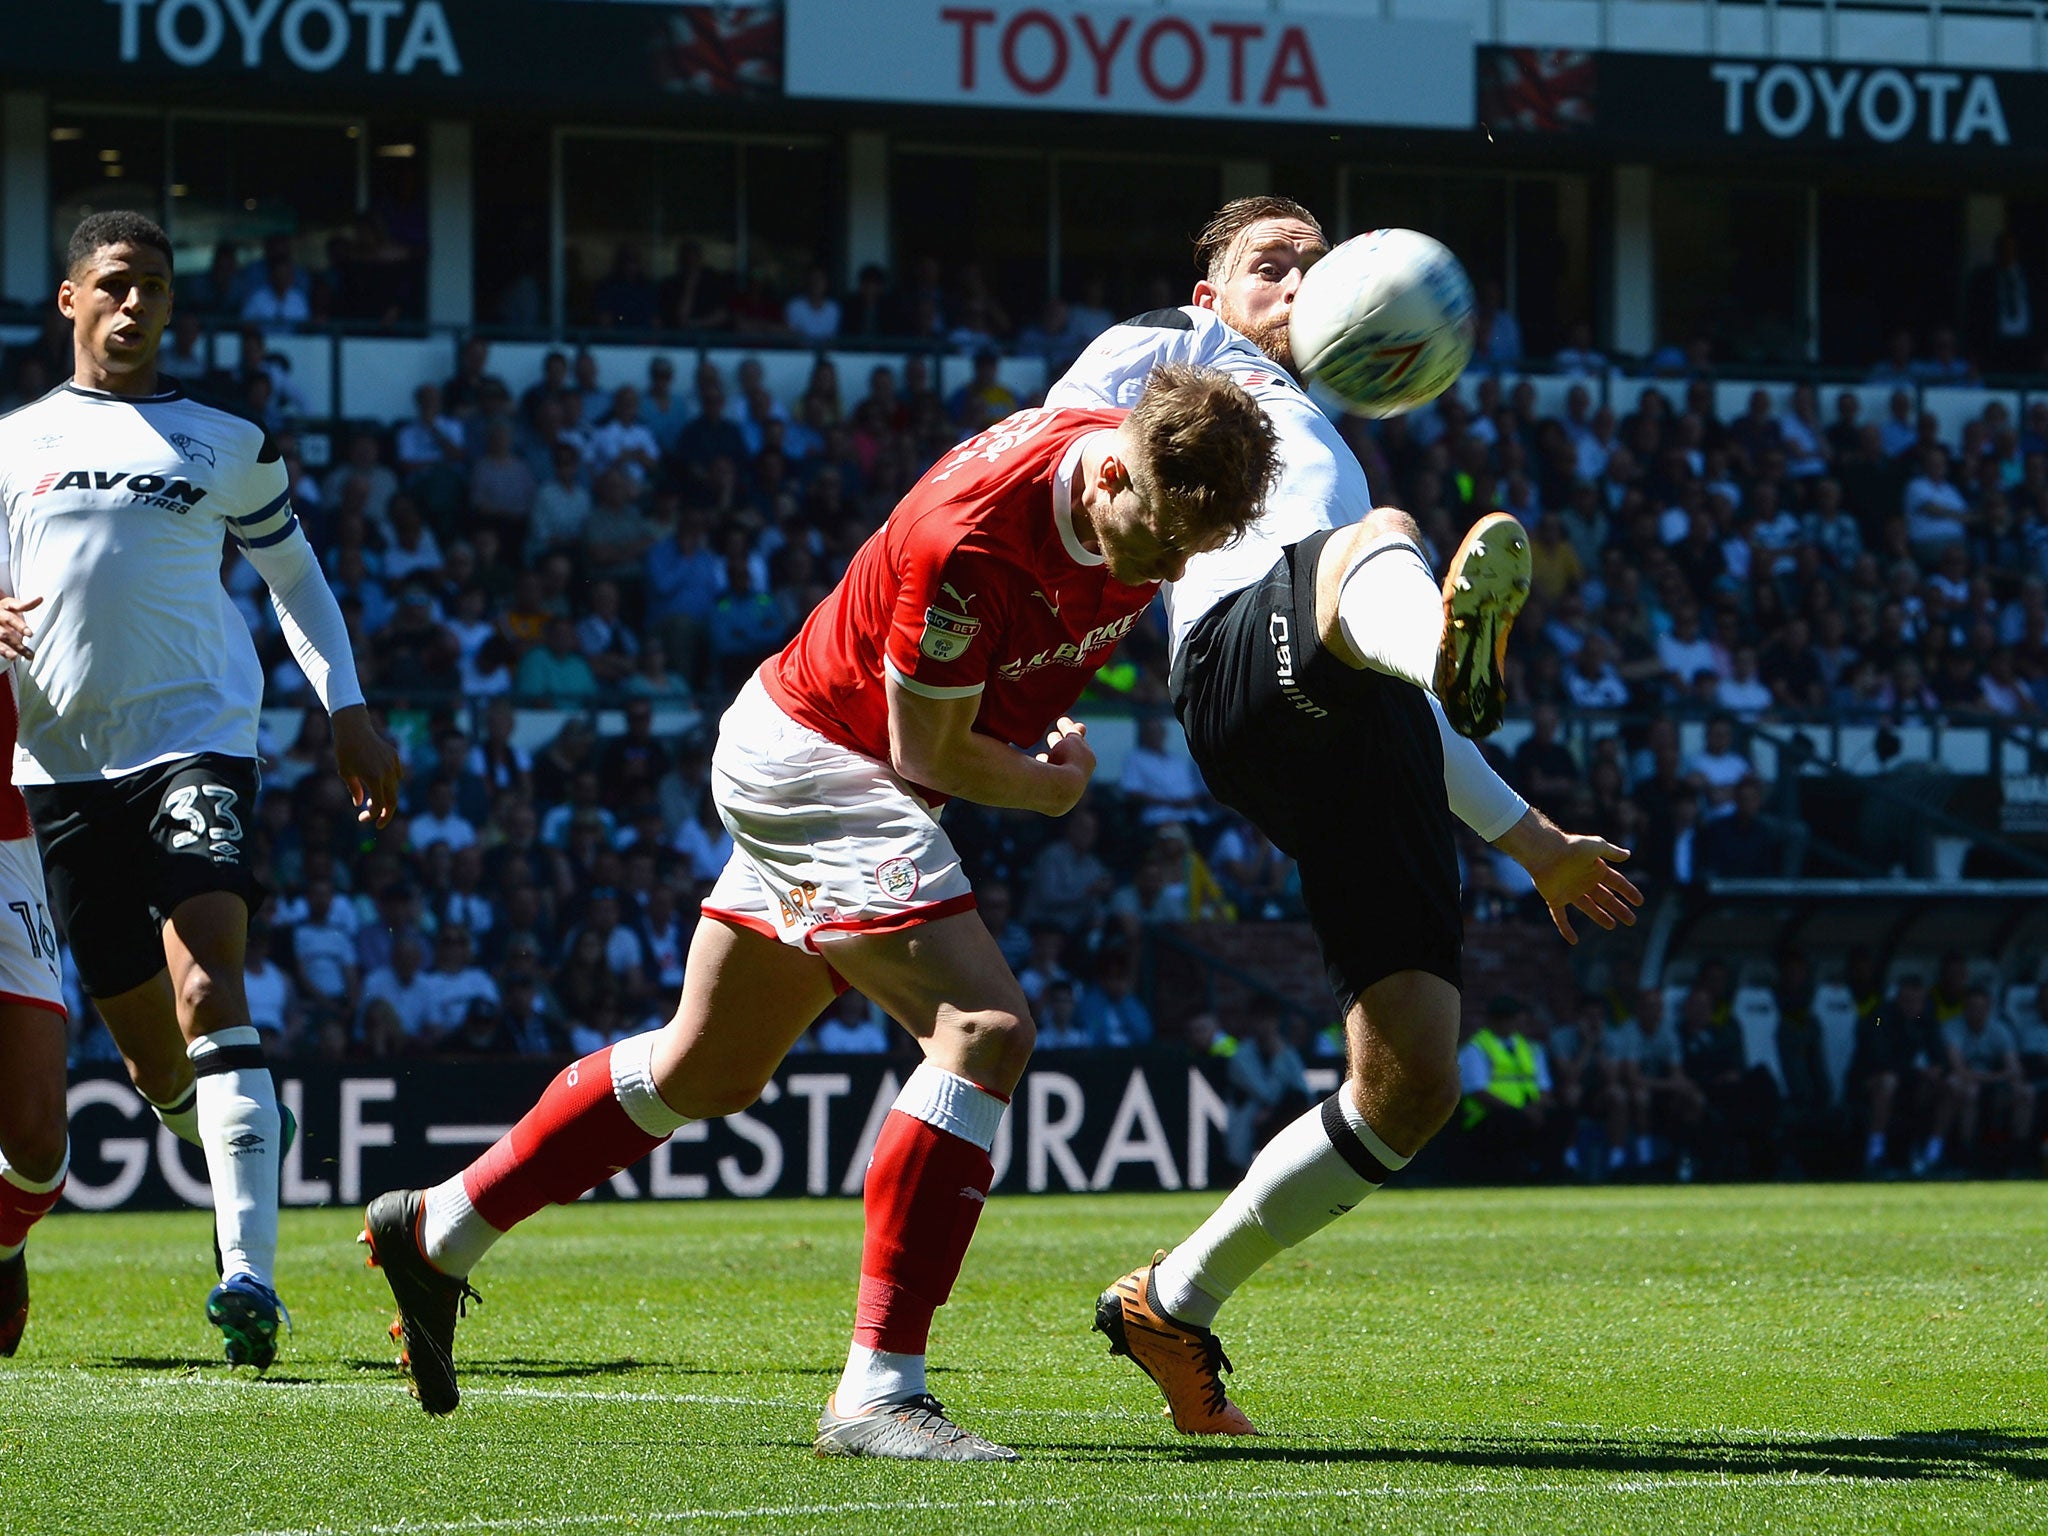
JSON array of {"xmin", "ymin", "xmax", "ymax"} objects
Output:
[{"xmin": 1124, "ymin": 362, "xmax": 1280, "ymax": 541}]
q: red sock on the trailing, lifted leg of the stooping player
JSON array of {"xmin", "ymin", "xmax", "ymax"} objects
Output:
[{"xmin": 463, "ymin": 1047, "xmax": 664, "ymax": 1233}]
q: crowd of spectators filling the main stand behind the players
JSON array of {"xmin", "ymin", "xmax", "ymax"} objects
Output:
[{"xmin": 12, "ymin": 285, "xmax": 2048, "ymax": 1179}]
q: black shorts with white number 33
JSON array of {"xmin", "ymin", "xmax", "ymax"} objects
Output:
[{"xmin": 23, "ymin": 752, "xmax": 262, "ymax": 997}]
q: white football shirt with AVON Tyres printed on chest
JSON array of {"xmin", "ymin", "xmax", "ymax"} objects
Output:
[{"xmin": 0, "ymin": 383, "xmax": 297, "ymax": 784}]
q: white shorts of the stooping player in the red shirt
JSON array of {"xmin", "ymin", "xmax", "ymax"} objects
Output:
[{"xmin": 705, "ymin": 676, "xmax": 975, "ymax": 954}]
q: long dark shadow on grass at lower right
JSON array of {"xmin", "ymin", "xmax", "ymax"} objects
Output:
[{"xmin": 1040, "ymin": 1430, "xmax": 2048, "ymax": 1483}]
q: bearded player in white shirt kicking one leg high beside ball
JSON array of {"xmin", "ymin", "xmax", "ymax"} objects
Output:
[{"xmin": 1047, "ymin": 197, "xmax": 1640, "ymax": 1434}]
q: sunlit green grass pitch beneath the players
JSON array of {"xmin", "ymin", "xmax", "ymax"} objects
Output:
[{"xmin": 0, "ymin": 1184, "xmax": 2048, "ymax": 1536}]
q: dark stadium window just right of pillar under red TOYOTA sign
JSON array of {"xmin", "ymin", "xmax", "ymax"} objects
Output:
[{"xmin": 889, "ymin": 145, "xmax": 1079, "ymax": 326}]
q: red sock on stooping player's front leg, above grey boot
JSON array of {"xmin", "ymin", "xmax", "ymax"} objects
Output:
[{"xmin": 854, "ymin": 1110, "xmax": 995, "ymax": 1354}]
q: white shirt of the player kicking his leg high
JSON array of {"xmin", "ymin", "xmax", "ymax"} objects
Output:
[{"xmin": 1044, "ymin": 305, "xmax": 1372, "ymax": 655}]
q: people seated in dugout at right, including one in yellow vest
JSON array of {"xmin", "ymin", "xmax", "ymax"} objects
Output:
[{"xmin": 1452, "ymin": 948, "xmax": 2048, "ymax": 1180}]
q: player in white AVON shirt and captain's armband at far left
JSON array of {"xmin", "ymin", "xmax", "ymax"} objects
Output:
[{"xmin": 0, "ymin": 213, "xmax": 399, "ymax": 1368}]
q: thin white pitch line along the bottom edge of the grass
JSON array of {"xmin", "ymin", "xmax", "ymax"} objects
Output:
[{"xmin": 220, "ymin": 1473, "xmax": 1884, "ymax": 1536}]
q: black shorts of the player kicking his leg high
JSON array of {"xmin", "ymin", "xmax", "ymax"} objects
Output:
[{"xmin": 1171, "ymin": 530, "xmax": 1464, "ymax": 1008}]
